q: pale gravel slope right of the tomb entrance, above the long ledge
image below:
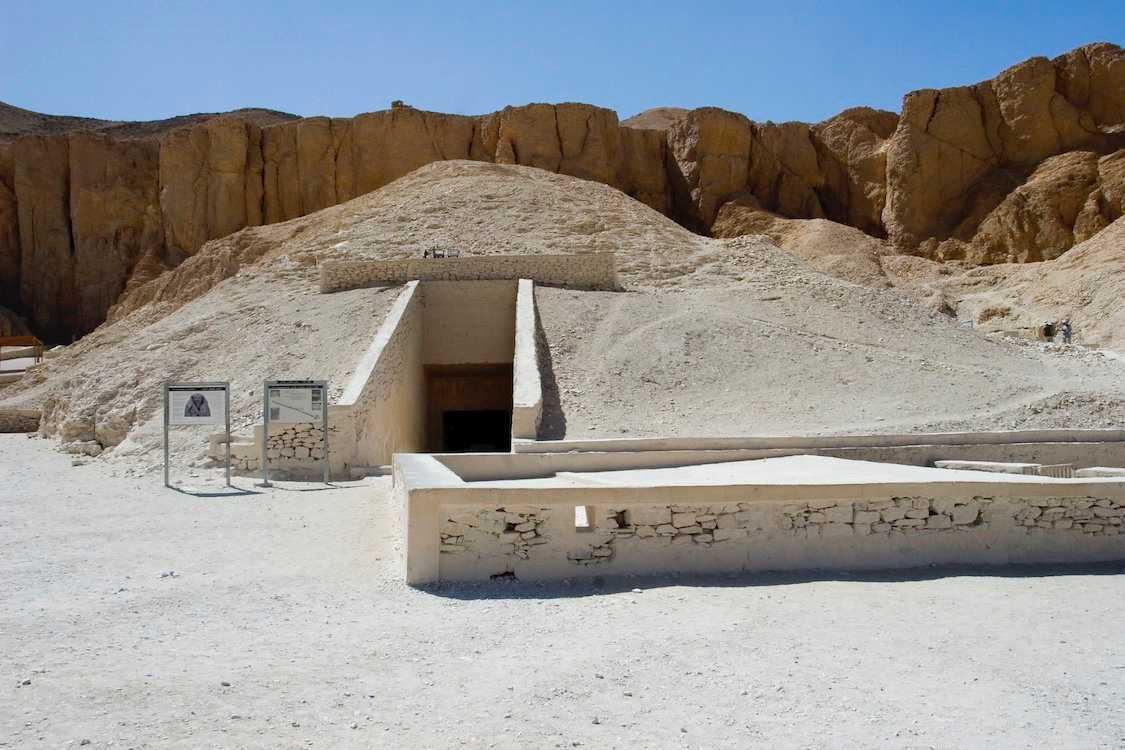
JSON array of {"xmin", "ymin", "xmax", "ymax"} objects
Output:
[{"xmin": 538, "ymin": 279, "xmax": 1125, "ymax": 439}]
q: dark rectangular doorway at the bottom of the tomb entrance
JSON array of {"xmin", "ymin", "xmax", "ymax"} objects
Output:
[{"xmin": 425, "ymin": 364, "xmax": 512, "ymax": 453}]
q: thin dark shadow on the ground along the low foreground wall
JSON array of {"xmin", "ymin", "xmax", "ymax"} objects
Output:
[{"xmin": 421, "ymin": 560, "xmax": 1125, "ymax": 600}]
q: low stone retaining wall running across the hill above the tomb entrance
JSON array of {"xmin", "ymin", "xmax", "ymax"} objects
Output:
[{"xmin": 321, "ymin": 253, "xmax": 618, "ymax": 292}]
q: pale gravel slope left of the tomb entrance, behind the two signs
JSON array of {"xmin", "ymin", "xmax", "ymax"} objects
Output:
[{"xmin": 0, "ymin": 264, "xmax": 398, "ymax": 461}]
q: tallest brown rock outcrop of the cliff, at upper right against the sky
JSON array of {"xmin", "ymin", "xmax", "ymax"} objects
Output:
[{"xmin": 883, "ymin": 44, "xmax": 1125, "ymax": 249}]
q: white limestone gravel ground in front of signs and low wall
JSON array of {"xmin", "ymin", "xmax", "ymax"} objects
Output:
[{"xmin": 0, "ymin": 435, "xmax": 1125, "ymax": 748}]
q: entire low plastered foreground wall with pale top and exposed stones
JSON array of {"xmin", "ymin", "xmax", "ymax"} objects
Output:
[{"xmin": 396, "ymin": 455, "xmax": 1125, "ymax": 585}]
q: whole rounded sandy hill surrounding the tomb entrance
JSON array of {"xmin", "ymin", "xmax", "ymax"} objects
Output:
[{"xmin": 0, "ymin": 161, "xmax": 1125, "ymax": 462}]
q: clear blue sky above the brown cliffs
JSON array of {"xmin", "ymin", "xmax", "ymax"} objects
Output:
[{"xmin": 0, "ymin": 0, "xmax": 1125, "ymax": 121}]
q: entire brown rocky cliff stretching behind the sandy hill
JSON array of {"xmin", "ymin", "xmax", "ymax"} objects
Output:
[{"xmin": 0, "ymin": 38, "xmax": 1125, "ymax": 338}]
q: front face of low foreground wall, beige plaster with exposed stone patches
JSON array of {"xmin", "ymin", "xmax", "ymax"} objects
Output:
[{"xmin": 418, "ymin": 488, "xmax": 1125, "ymax": 584}]
